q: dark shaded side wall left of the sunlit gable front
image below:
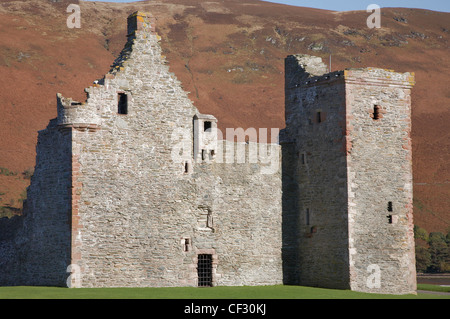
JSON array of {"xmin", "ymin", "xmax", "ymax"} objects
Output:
[{"xmin": 0, "ymin": 120, "xmax": 71, "ymax": 286}]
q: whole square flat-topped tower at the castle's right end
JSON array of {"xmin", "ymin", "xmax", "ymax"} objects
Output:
[{"xmin": 283, "ymin": 55, "xmax": 416, "ymax": 294}]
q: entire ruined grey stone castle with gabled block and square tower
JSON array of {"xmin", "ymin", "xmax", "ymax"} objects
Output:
[{"xmin": 0, "ymin": 12, "xmax": 416, "ymax": 294}]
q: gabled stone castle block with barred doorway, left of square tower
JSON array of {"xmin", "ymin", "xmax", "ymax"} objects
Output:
[{"xmin": 0, "ymin": 12, "xmax": 282, "ymax": 287}]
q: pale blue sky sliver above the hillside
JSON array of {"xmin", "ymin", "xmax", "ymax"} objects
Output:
[{"xmin": 84, "ymin": 0, "xmax": 450, "ymax": 12}]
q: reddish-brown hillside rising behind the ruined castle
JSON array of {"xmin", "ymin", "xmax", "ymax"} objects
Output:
[{"xmin": 0, "ymin": 0, "xmax": 450, "ymax": 232}]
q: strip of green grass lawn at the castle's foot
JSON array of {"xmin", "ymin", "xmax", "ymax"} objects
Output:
[{"xmin": 0, "ymin": 285, "xmax": 450, "ymax": 299}]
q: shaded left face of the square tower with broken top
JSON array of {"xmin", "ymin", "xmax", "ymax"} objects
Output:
[{"xmin": 283, "ymin": 56, "xmax": 350, "ymax": 289}]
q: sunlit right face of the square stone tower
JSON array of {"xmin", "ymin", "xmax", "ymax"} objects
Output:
[{"xmin": 345, "ymin": 68, "xmax": 416, "ymax": 293}]
